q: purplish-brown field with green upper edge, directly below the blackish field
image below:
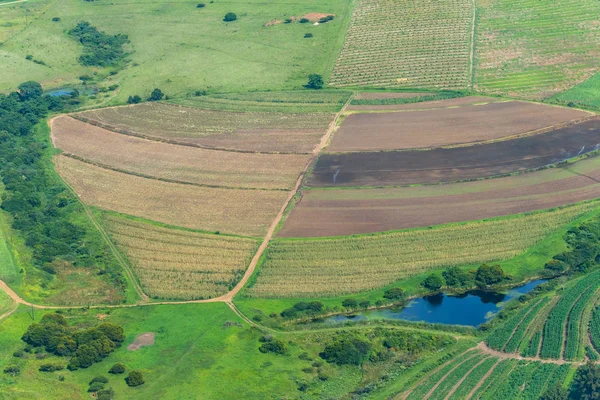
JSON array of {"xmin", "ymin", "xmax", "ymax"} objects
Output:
[{"xmin": 279, "ymin": 158, "xmax": 600, "ymax": 237}]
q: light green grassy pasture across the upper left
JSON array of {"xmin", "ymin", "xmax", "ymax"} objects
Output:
[{"xmin": 0, "ymin": 0, "xmax": 351, "ymax": 101}]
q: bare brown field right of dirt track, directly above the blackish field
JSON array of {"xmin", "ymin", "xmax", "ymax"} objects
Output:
[{"xmin": 327, "ymin": 99, "xmax": 590, "ymax": 152}]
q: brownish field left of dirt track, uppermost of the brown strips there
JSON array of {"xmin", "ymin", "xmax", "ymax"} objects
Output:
[{"xmin": 75, "ymin": 103, "xmax": 333, "ymax": 153}]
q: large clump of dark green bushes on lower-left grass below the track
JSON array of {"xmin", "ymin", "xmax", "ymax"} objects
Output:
[{"xmin": 21, "ymin": 313, "xmax": 125, "ymax": 370}]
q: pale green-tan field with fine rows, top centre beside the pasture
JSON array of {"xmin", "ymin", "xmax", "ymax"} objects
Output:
[{"xmin": 329, "ymin": 0, "xmax": 474, "ymax": 89}]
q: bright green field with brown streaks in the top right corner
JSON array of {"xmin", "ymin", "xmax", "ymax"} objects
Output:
[{"xmin": 474, "ymin": 0, "xmax": 600, "ymax": 99}]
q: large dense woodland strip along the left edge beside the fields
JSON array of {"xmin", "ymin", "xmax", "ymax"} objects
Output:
[{"xmin": 0, "ymin": 82, "xmax": 125, "ymax": 289}]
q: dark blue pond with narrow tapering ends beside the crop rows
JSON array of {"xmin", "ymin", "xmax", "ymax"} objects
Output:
[{"xmin": 325, "ymin": 279, "xmax": 546, "ymax": 326}]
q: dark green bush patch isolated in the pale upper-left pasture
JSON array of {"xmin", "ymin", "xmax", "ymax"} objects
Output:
[{"xmin": 69, "ymin": 21, "xmax": 129, "ymax": 67}]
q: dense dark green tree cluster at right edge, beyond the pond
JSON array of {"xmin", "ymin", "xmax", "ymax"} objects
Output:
[{"xmin": 545, "ymin": 219, "xmax": 600, "ymax": 275}]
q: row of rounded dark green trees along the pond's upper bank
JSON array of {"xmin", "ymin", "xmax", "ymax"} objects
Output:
[{"xmin": 421, "ymin": 264, "xmax": 509, "ymax": 291}]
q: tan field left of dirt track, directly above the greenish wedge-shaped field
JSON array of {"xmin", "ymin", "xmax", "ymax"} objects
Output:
[{"xmin": 55, "ymin": 156, "xmax": 288, "ymax": 236}]
